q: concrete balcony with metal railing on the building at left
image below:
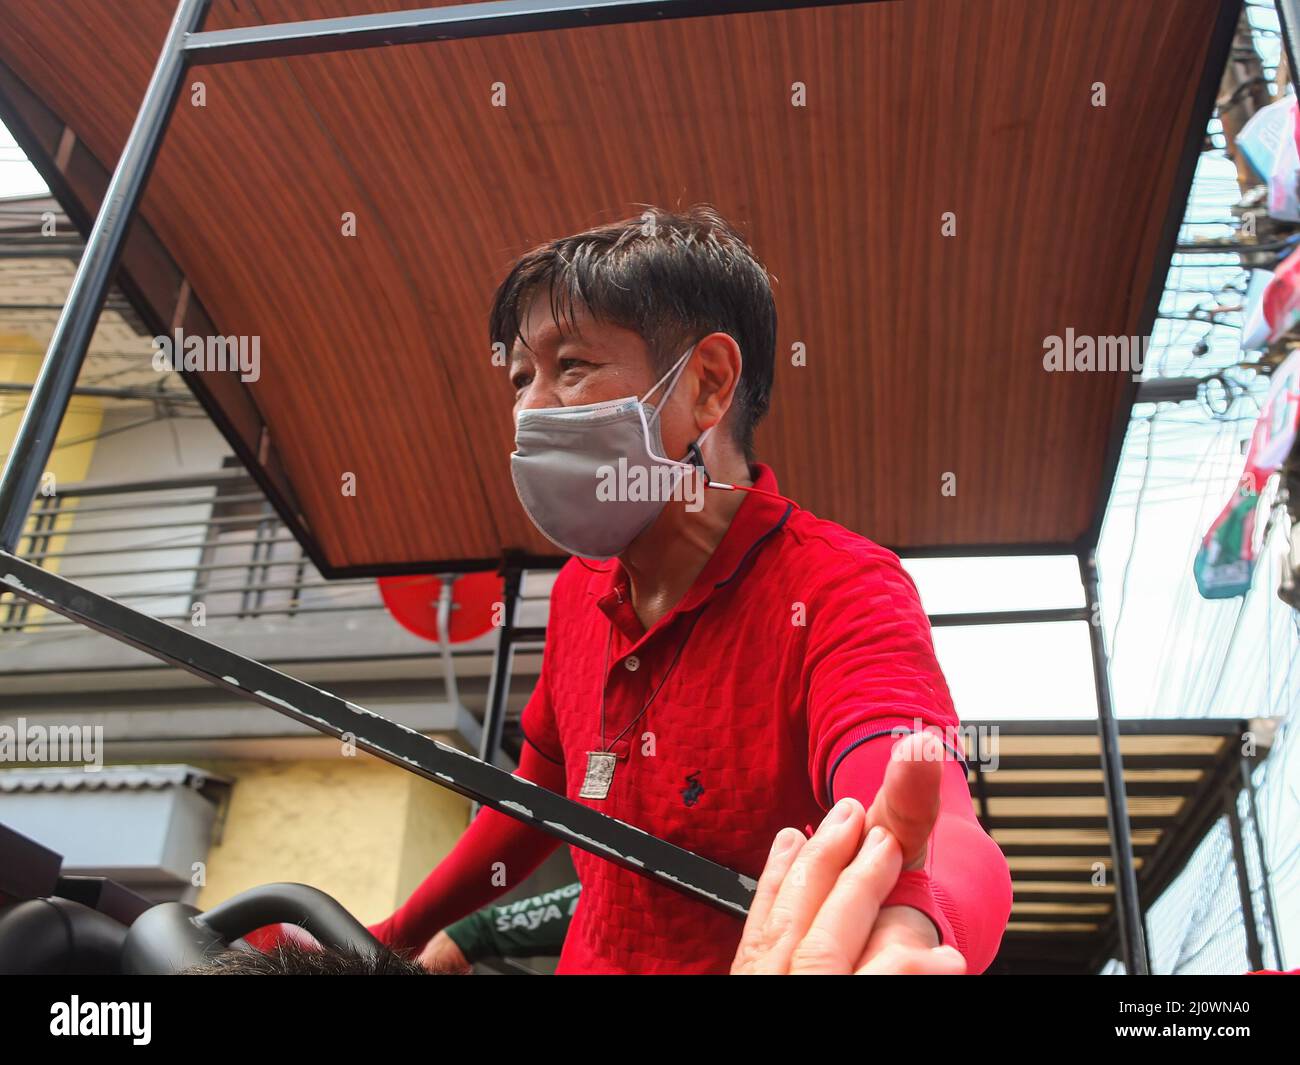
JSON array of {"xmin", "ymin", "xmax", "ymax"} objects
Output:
[{"xmin": 0, "ymin": 469, "xmax": 553, "ymax": 762}]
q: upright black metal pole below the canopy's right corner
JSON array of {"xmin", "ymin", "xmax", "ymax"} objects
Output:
[{"xmin": 1079, "ymin": 551, "xmax": 1151, "ymax": 977}]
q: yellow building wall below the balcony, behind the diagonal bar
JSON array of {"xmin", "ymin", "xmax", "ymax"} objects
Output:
[{"xmin": 194, "ymin": 754, "xmax": 469, "ymax": 925}]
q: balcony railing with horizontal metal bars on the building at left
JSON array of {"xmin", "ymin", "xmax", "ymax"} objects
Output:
[{"xmin": 0, "ymin": 469, "xmax": 384, "ymax": 633}]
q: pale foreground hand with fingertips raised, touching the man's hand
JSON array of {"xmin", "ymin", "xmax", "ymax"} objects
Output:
[{"xmin": 732, "ymin": 798, "xmax": 966, "ymax": 975}]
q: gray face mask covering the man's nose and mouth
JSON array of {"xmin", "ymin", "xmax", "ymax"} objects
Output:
[{"xmin": 510, "ymin": 345, "xmax": 712, "ymax": 559}]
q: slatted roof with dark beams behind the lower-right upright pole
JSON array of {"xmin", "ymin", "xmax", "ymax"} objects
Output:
[{"xmin": 967, "ymin": 718, "xmax": 1253, "ymax": 973}]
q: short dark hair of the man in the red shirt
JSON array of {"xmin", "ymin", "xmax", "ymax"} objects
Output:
[{"xmin": 488, "ymin": 204, "xmax": 776, "ymax": 460}]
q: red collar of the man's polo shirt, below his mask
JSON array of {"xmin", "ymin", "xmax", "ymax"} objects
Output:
[{"xmin": 586, "ymin": 463, "xmax": 794, "ymax": 627}]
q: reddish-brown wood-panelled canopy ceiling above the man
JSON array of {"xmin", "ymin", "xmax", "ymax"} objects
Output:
[{"xmin": 0, "ymin": 0, "xmax": 1238, "ymax": 575}]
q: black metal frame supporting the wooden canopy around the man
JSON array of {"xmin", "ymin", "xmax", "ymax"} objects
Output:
[{"xmin": 0, "ymin": 0, "xmax": 1242, "ymax": 974}]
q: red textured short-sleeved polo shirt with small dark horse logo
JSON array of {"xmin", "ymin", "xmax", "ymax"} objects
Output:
[{"xmin": 523, "ymin": 464, "xmax": 957, "ymax": 973}]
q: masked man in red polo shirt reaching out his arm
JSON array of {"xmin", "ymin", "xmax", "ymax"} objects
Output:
[{"xmin": 372, "ymin": 208, "xmax": 1010, "ymax": 973}]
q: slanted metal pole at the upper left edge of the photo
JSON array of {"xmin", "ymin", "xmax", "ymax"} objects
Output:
[{"xmin": 0, "ymin": 0, "xmax": 212, "ymax": 551}]
